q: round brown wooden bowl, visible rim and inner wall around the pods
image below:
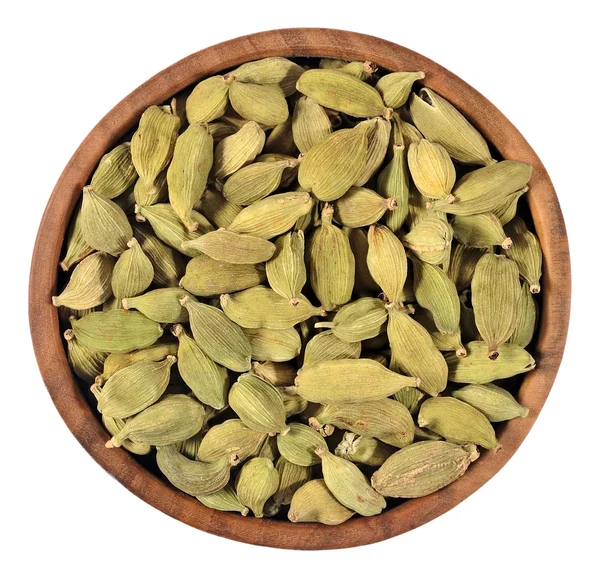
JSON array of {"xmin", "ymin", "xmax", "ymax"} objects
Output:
[{"xmin": 29, "ymin": 29, "xmax": 571, "ymax": 549}]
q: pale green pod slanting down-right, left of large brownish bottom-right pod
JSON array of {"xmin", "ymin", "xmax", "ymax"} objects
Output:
[{"xmin": 316, "ymin": 447, "xmax": 386, "ymax": 516}]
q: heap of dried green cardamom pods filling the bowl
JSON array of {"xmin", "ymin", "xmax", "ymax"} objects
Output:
[{"xmin": 52, "ymin": 58, "xmax": 542, "ymax": 524}]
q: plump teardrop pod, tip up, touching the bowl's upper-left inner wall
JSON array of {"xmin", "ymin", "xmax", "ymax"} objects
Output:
[{"xmin": 81, "ymin": 187, "xmax": 133, "ymax": 256}]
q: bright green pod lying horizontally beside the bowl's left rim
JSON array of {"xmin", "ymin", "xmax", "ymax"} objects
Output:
[{"xmin": 71, "ymin": 309, "xmax": 163, "ymax": 353}]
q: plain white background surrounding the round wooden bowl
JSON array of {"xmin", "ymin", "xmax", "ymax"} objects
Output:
[{"xmin": 0, "ymin": 0, "xmax": 600, "ymax": 585}]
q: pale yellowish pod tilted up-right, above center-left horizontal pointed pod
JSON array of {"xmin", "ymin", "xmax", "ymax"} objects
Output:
[{"xmin": 227, "ymin": 192, "xmax": 313, "ymax": 240}]
